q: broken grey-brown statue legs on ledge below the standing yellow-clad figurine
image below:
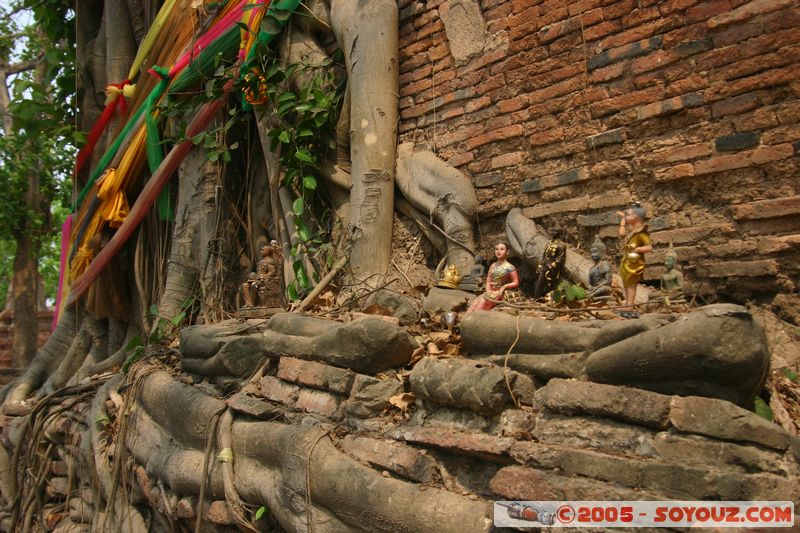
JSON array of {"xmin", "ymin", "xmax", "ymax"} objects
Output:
[{"xmin": 461, "ymin": 304, "xmax": 769, "ymax": 407}]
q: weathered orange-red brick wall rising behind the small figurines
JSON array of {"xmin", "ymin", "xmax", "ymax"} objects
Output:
[{"xmin": 399, "ymin": 0, "xmax": 800, "ymax": 298}]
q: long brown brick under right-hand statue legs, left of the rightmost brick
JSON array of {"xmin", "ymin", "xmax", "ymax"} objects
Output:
[{"xmin": 536, "ymin": 379, "xmax": 670, "ymax": 429}]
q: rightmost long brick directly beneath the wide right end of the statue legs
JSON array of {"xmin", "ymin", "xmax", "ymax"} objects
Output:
[{"xmin": 669, "ymin": 396, "xmax": 792, "ymax": 450}]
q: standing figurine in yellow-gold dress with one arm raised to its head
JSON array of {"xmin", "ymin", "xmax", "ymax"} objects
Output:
[{"xmin": 617, "ymin": 202, "xmax": 653, "ymax": 305}]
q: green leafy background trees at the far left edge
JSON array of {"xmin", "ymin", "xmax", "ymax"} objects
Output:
[{"xmin": 0, "ymin": 0, "xmax": 77, "ymax": 308}]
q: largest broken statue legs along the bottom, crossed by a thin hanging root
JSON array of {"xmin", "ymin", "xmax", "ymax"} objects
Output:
[{"xmin": 126, "ymin": 371, "xmax": 491, "ymax": 533}]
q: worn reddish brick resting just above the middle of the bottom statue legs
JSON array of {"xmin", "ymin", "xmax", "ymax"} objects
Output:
[{"xmin": 341, "ymin": 435, "xmax": 436, "ymax": 483}]
